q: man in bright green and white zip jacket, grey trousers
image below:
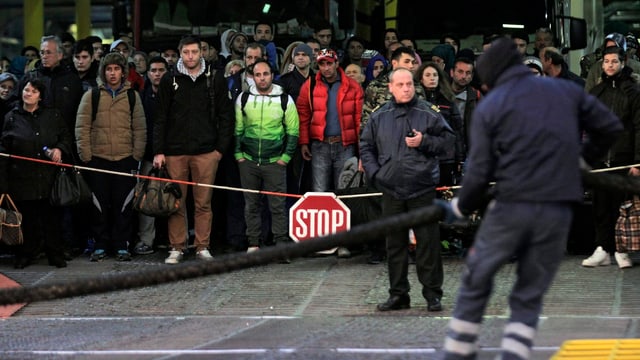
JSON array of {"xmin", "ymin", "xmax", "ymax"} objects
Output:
[{"xmin": 235, "ymin": 59, "xmax": 300, "ymax": 252}]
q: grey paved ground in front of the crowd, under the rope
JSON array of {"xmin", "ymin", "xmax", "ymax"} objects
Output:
[{"xmin": 0, "ymin": 252, "xmax": 640, "ymax": 359}]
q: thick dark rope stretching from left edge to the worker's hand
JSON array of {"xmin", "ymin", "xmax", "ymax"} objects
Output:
[{"xmin": 0, "ymin": 206, "xmax": 442, "ymax": 305}]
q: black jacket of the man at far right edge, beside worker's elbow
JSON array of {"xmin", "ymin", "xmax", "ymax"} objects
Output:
[{"xmin": 589, "ymin": 67, "xmax": 640, "ymax": 165}]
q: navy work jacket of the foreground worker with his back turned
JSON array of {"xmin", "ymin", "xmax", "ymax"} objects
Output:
[{"xmin": 458, "ymin": 64, "xmax": 622, "ymax": 214}]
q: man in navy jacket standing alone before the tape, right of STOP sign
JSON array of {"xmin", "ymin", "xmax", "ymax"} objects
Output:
[{"xmin": 360, "ymin": 68, "xmax": 455, "ymax": 311}]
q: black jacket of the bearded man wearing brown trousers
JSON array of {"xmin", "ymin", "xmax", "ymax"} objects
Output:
[{"xmin": 153, "ymin": 63, "xmax": 234, "ymax": 155}]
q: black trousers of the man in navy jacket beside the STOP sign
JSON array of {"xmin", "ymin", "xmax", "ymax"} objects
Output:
[{"xmin": 382, "ymin": 191, "xmax": 444, "ymax": 300}]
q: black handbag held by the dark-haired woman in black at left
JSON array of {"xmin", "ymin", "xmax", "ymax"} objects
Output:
[{"xmin": 49, "ymin": 167, "xmax": 93, "ymax": 206}]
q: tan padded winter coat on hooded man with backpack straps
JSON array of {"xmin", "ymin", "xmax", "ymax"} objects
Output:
[{"xmin": 76, "ymin": 81, "xmax": 147, "ymax": 162}]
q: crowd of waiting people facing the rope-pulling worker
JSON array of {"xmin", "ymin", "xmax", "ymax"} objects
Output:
[{"xmin": 0, "ymin": 15, "xmax": 640, "ymax": 336}]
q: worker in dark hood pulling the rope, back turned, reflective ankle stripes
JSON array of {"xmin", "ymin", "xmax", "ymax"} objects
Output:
[{"xmin": 438, "ymin": 38, "xmax": 622, "ymax": 359}]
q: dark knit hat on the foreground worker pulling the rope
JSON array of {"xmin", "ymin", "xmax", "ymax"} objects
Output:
[{"xmin": 476, "ymin": 37, "xmax": 523, "ymax": 87}]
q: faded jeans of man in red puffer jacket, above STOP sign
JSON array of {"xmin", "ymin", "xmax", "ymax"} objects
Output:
[{"xmin": 311, "ymin": 140, "xmax": 356, "ymax": 191}]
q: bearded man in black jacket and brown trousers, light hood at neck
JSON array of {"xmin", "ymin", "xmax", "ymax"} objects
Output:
[{"xmin": 153, "ymin": 36, "xmax": 233, "ymax": 264}]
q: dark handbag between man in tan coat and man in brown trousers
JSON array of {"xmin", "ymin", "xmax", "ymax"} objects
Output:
[{"xmin": 133, "ymin": 167, "xmax": 182, "ymax": 217}]
